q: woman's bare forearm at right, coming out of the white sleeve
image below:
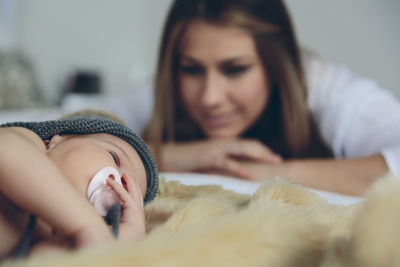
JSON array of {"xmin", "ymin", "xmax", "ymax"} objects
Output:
[{"xmin": 255, "ymin": 155, "xmax": 388, "ymax": 196}]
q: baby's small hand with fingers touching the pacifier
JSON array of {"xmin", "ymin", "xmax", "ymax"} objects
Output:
[{"xmin": 107, "ymin": 174, "xmax": 146, "ymax": 243}]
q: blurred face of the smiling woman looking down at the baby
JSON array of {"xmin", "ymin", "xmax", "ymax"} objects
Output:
[{"xmin": 178, "ymin": 21, "xmax": 270, "ymax": 138}]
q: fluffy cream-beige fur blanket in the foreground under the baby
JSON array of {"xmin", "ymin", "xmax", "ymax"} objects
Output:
[{"xmin": 4, "ymin": 177, "xmax": 400, "ymax": 267}]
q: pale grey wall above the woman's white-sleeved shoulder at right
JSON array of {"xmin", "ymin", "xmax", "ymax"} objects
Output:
[{"xmin": 285, "ymin": 0, "xmax": 400, "ymax": 97}]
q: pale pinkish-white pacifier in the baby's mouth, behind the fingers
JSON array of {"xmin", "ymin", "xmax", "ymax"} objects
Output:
[{"xmin": 87, "ymin": 167, "xmax": 122, "ymax": 216}]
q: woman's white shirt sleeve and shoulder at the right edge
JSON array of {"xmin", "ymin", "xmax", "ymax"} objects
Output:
[{"xmin": 305, "ymin": 58, "xmax": 400, "ymax": 176}]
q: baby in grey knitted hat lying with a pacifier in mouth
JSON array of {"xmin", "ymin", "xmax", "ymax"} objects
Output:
[{"xmin": 0, "ymin": 111, "xmax": 158, "ymax": 258}]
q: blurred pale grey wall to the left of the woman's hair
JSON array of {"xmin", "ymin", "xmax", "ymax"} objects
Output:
[{"xmin": 20, "ymin": 0, "xmax": 170, "ymax": 103}]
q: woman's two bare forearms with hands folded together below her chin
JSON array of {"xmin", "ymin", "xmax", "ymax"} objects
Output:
[{"xmin": 162, "ymin": 140, "xmax": 388, "ymax": 195}]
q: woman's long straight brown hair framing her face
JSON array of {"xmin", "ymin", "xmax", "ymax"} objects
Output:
[{"xmin": 144, "ymin": 0, "xmax": 332, "ymax": 163}]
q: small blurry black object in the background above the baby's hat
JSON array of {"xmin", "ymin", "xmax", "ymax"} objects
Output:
[{"xmin": 66, "ymin": 71, "xmax": 102, "ymax": 94}]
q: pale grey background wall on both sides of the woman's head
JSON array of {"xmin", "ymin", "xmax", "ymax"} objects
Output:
[{"xmin": 15, "ymin": 0, "xmax": 400, "ymax": 103}]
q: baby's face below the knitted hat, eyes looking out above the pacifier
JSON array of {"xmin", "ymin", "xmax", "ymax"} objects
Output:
[{"xmin": 47, "ymin": 133, "xmax": 147, "ymax": 198}]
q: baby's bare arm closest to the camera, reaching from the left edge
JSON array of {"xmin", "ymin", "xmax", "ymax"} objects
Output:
[{"xmin": 0, "ymin": 127, "xmax": 113, "ymax": 249}]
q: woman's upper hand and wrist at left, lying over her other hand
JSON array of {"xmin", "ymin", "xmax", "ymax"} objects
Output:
[{"xmin": 161, "ymin": 139, "xmax": 282, "ymax": 179}]
